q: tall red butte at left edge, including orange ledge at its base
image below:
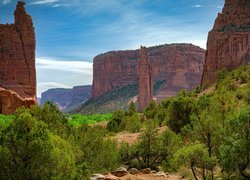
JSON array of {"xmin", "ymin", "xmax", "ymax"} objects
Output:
[{"xmin": 0, "ymin": 1, "xmax": 36, "ymax": 114}]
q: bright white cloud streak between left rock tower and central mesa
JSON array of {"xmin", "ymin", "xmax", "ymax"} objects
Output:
[{"xmin": 36, "ymin": 58, "xmax": 93, "ymax": 74}]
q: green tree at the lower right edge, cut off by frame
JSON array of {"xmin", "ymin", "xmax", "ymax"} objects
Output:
[{"xmin": 220, "ymin": 107, "xmax": 250, "ymax": 179}]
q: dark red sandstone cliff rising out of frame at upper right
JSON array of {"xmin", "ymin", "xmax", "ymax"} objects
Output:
[{"xmin": 201, "ymin": 0, "xmax": 250, "ymax": 89}]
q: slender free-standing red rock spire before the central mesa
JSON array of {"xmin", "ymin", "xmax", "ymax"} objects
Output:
[{"xmin": 138, "ymin": 47, "xmax": 153, "ymax": 112}]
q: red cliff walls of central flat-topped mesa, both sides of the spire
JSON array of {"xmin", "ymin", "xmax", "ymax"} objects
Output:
[{"xmin": 92, "ymin": 44, "xmax": 205, "ymax": 101}]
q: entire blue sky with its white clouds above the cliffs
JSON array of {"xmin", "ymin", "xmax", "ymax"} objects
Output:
[{"xmin": 0, "ymin": 0, "xmax": 224, "ymax": 96}]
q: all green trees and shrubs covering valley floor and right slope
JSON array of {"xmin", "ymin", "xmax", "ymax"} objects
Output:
[{"xmin": 0, "ymin": 66, "xmax": 250, "ymax": 179}]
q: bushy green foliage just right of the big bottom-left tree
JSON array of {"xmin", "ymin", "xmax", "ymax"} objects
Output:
[{"xmin": 71, "ymin": 125, "xmax": 118, "ymax": 174}]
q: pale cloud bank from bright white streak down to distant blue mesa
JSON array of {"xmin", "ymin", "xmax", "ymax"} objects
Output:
[{"xmin": 36, "ymin": 58, "xmax": 93, "ymax": 97}]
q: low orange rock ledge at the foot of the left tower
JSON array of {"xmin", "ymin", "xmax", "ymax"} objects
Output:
[{"xmin": 0, "ymin": 88, "xmax": 36, "ymax": 114}]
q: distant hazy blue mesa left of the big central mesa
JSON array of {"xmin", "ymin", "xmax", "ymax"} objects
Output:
[{"xmin": 40, "ymin": 85, "xmax": 92, "ymax": 110}]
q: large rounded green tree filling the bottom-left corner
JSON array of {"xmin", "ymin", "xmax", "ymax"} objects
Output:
[{"xmin": 0, "ymin": 110, "xmax": 75, "ymax": 179}]
